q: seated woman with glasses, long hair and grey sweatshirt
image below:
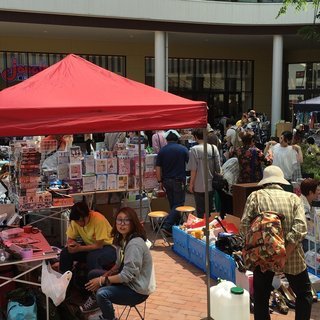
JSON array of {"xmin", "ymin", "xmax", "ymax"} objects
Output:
[{"xmin": 80, "ymin": 207, "xmax": 155, "ymax": 320}]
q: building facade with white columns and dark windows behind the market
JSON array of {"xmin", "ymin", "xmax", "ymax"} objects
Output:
[{"xmin": 0, "ymin": 0, "xmax": 320, "ymax": 134}]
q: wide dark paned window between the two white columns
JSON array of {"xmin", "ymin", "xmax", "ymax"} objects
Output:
[{"xmin": 145, "ymin": 57, "xmax": 254, "ymax": 119}]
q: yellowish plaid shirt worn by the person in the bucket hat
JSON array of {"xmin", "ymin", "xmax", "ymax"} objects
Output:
[{"xmin": 240, "ymin": 184, "xmax": 307, "ymax": 275}]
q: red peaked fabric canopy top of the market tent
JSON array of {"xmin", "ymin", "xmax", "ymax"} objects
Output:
[{"xmin": 0, "ymin": 54, "xmax": 207, "ymax": 137}]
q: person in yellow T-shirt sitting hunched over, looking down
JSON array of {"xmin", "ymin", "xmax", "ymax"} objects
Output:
[{"xmin": 59, "ymin": 201, "xmax": 116, "ymax": 273}]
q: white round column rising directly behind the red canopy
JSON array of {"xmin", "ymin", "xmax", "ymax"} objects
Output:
[{"xmin": 154, "ymin": 31, "xmax": 168, "ymax": 91}]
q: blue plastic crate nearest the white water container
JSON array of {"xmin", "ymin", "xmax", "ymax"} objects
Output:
[{"xmin": 210, "ymin": 246, "xmax": 236, "ymax": 283}]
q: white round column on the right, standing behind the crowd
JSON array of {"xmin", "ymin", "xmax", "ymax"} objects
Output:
[{"xmin": 271, "ymin": 35, "xmax": 283, "ymax": 136}]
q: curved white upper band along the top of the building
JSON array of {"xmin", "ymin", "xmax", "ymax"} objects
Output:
[{"xmin": 0, "ymin": 0, "xmax": 313, "ymax": 25}]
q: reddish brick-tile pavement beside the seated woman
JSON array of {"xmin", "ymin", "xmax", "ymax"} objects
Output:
[{"xmin": 122, "ymin": 224, "xmax": 320, "ymax": 320}]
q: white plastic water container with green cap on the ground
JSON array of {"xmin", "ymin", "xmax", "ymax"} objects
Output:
[{"xmin": 210, "ymin": 281, "xmax": 250, "ymax": 320}]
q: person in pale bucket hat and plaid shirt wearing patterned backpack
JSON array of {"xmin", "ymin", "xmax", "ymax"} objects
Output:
[{"xmin": 240, "ymin": 165, "xmax": 312, "ymax": 320}]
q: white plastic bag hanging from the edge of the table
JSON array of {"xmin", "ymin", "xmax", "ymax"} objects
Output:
[{"xmin": 41, "ymin": 261, "xmax": 72, "ymax": 306}]
